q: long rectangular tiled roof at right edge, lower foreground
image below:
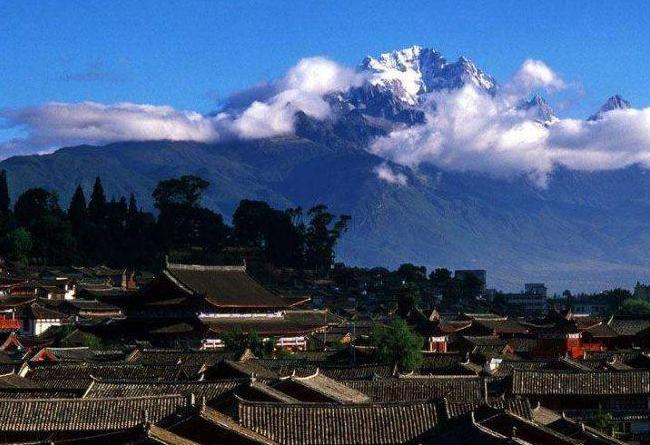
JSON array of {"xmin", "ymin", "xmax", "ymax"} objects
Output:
[{"xmin": 512, "ymin": 370, "xmax": 650, "ymax": 396}]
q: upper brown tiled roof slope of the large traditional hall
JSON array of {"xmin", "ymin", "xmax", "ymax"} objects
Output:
[{"xmin": 163, "ymin": 264, "xmax": 288, "ymax": 308}]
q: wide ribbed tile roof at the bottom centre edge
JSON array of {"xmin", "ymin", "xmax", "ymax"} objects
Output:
[{"xmin": 237, "ymin": 400, "xmax": 437, "ymax": 445}]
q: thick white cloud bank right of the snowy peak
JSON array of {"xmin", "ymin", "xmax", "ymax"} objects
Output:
[{"xmin": 370, "ymin": 60, "xmax": 650, "ymax": 187}]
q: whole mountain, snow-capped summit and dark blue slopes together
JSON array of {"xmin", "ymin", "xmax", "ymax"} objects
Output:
[{"xmin": 0, "ymin": 47, "xmax": 650, "ymax": 292}]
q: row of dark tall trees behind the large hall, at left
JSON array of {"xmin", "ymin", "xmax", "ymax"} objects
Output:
[{"xmin": 0, "ymin": 172, "xmax": 349, "ymax": 274}]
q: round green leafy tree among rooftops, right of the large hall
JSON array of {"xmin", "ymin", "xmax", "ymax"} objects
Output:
[{"xmin": 371, "ymin": 319, "xmax": 424, "ymax": 372}]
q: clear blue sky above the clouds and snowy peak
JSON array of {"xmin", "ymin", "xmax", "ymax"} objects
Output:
[{"xmin": 0, "ymin": 0, "xmax": 650, "ymax": 116}]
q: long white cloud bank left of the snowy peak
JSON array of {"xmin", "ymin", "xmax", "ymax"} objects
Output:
[{"xmin": 0, "ymin": 57, "xmax": 363, "ymax": 158}]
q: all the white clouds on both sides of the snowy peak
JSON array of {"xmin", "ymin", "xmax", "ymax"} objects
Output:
[{"xmin": 0, "ymin": 51, "xmax": 650, "ymax": 187}]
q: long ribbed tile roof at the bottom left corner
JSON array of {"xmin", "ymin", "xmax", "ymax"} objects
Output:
[{"xmin": 0, "ymin": 396, "xmax": 186, "ymax": 432}]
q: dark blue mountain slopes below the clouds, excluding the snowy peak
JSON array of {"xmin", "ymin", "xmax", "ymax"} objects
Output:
[{"xmin": 0, "ymin": 138, "xmax": 650, "ymax": 290}]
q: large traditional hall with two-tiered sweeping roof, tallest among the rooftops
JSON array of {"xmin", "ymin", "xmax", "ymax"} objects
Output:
[{"xmin": 135, "ymin": 263, "xmax": 332, "ymax": 350}]
